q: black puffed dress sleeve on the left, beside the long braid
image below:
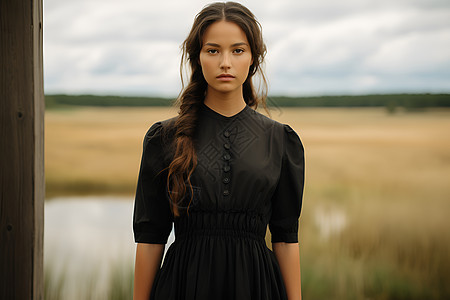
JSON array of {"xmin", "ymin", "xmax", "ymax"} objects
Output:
[{"xmin": 133, "ymin": 122, "xmax": 173, "ymax": 244}]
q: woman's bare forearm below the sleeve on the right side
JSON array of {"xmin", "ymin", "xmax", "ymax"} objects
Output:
[{"xmin": 272, "ymin": 243, "xmax": 302, "ymax": 300}]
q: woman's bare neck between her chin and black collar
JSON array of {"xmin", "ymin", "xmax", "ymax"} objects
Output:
[{"xmin": 204, "ymin": 87, "xmax": 246, "ymax": 117}]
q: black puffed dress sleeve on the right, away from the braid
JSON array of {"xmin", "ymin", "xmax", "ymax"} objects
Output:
[{"xmin": 269, "ymin": 125, "xmax": 305, "ymax": 243}]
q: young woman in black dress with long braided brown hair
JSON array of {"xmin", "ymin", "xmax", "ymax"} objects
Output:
[{"xmin": 133, "ymin": 2, "xmax": 304, "ymax": 300}]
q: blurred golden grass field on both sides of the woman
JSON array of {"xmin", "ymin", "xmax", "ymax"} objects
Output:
[{"xmin": 46, "ymin": 107, "xmax": 450, "ymax": 299}]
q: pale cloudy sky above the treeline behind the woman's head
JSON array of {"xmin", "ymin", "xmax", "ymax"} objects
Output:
[{"xmin": 44, "ymin": 0, "xmax": 450, "ymax": 97}]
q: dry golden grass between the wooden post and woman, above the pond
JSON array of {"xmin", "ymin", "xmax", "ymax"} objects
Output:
[{"xmin": 45, "ymin": 107, "xmax": 176, "ymax": 196}]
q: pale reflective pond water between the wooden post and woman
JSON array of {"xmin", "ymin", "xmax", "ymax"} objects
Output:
[{"xmin": 44, "ymin": 197, "xmax": 174, "ymax": 299}]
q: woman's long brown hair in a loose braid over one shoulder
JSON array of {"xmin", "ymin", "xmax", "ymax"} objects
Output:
[{"xmin": 167, "ymin": 2, "xmax": 267, "ymax": 216}]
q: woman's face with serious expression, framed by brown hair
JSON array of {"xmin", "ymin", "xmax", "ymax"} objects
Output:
[{"xmin": 200, "ymin": 21, "xmax": 253, "ymax": 93}]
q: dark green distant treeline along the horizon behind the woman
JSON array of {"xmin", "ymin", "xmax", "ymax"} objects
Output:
[{"xmin": 45, "ymin": 94, "xmax": 450, "ymax": 111}]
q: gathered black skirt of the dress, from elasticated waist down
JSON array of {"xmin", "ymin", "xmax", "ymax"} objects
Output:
[{"xmin": 150, "ymin": 212, "xmax": 287, "ymax": 300}]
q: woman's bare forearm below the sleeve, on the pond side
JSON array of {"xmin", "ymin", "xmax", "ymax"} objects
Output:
[{"xmin": 133, "ymin": 243, "xmax": 165, "ymax": 300}]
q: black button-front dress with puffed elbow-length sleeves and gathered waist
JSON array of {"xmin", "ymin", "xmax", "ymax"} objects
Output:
[{"xmin": 133, "ymin": 104, "xmax": 304, "ymax": 300}]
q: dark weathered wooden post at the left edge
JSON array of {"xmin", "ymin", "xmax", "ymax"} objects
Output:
[{"xmin": 0, "ymin": 0, "xmax": 44, "ymax": 299}]
